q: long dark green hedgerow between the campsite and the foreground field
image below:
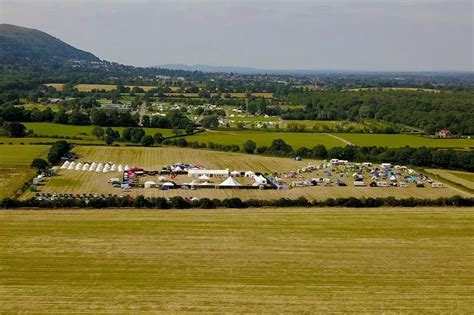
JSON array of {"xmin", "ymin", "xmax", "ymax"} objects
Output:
[{"xmin": 0, "ymin": 195, "xmax": 474, "ymax": 209}]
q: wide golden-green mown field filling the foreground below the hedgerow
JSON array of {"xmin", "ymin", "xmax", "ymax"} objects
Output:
[{"xmin": 0, "ymin": 208, "xmax": 474, "ymax": 314}]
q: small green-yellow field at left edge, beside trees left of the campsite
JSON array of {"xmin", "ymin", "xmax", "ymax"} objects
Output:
[{"xmin": 0, "ymin": 144, "xmax": 49, "ymax": 199}]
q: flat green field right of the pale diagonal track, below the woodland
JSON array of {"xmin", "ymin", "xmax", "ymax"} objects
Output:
[{"xmin": 334, "ymin": 133, "xmax": 474, "ymax": 149}]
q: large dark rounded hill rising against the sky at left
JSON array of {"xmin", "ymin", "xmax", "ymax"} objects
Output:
[{"xmin": 0, "ymin": 24, "xmax": 100, "ymax": 63}]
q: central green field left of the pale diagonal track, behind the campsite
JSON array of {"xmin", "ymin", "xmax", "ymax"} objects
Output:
[{"xmin": 187, "ymin": 130, "xmax": 345, "ymax": 148}]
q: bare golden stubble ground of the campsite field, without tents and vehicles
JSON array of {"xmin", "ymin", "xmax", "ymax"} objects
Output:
[{"xmin": 23, "ymin": 146, "xmax": 470, "ymax": 200}]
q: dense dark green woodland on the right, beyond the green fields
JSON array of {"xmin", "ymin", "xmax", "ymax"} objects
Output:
[{"xmin": 281, "ymin": 91, "xmax": 474, "ymax": 135}]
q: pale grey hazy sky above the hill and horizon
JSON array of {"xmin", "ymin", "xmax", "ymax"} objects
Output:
[{"xmin": 0, "ymin": 0, "xmax": 474, "ymax": 71}]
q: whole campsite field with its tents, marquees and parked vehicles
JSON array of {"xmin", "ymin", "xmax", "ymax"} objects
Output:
[{"xmin": 22, "ymin": 146, "xmax": 469, "ymax": 200}]
